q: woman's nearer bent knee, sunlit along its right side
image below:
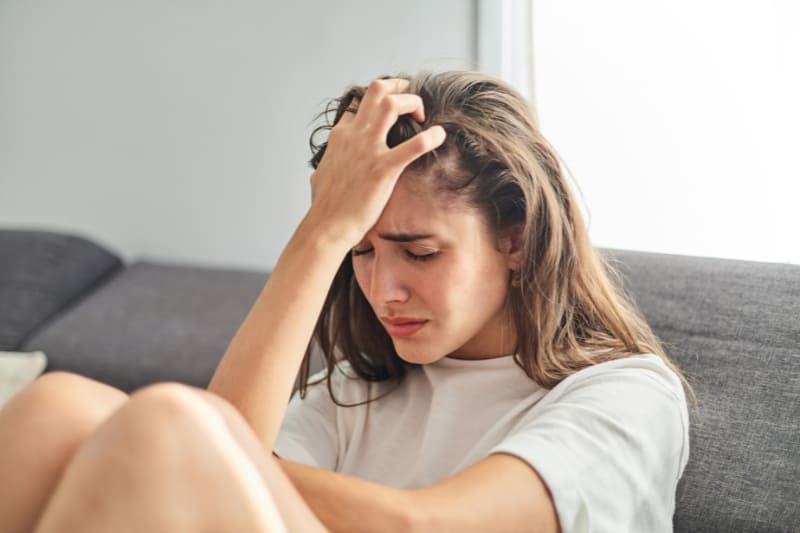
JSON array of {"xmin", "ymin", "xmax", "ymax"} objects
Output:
[{"xmin": 37, "ymin": 383, "xmax": 288, "ymax": 531}]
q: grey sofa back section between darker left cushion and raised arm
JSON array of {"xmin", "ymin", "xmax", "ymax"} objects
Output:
[{"xmin": 24, "ymin": 262, "xmax": 269, "ymax": 391}]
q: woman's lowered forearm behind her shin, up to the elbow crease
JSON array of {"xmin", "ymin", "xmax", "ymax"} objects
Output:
[{"xmin": 277, "ymin": 459, "xmax": 415, "ymax": 533}]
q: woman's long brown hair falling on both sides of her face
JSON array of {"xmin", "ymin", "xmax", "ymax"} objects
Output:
[{"xmin": 299, "ymin": 71, "xmax": 693, "ymax": 403}]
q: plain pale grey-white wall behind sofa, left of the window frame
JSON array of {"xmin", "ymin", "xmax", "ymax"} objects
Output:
[{"xmin": 0, "ymin": 0, "xmax": 476, "ymax": 269}]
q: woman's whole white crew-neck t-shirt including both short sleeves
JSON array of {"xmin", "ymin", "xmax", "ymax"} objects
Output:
[{"xmin": 274, "ymin": 355, "xmax": 689, "ymax": 533}]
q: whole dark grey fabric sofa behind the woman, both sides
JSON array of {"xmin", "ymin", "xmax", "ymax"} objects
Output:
[{"xmin": 0, "ymin": 229, "xmax": 800, "ymax": 532}]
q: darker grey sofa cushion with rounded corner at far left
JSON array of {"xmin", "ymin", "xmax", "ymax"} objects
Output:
[{"xmin": 0, "ymin": 229, "xmax": 122, "ymax": 350}]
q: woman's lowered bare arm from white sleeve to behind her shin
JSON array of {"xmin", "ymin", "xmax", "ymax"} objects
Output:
[{"xmin": 277, "ymin": 454, "xmax": 560, "ymax": 533}]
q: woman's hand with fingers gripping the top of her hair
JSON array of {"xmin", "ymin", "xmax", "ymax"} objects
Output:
[{"xmin": 307, "ymin": 79, "xmax": 445, "ymax": 248}]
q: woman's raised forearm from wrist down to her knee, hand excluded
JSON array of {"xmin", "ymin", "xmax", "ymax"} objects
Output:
[{"xmin": 208, "ymin": 212, "xmax": 346, "ymax": 450}]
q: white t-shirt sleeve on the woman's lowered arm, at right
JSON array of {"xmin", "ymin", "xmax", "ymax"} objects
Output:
[{"xmin": 489, "ymin": 356, "xmax": 689, "ymax": 533}]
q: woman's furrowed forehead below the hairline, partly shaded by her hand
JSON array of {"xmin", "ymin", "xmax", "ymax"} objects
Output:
[{"xmin": 374, "ymin": 171, "xmax": 486, "ymax": 237}]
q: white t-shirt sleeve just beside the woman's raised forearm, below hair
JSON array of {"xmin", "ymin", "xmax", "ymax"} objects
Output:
[{"xmin": 272, "ymin": 373, "xmax": 338, "ymax": 470}]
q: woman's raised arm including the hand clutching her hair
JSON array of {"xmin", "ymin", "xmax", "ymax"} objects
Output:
[{"xmin": 209, "ymin": 80, "xmax": 445, "ymax": 450}]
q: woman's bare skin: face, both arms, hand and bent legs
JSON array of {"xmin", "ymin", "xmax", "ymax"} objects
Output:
[{"xmin": 0, "ymin": 80, "xmax": 557, "ymax": 532}]
